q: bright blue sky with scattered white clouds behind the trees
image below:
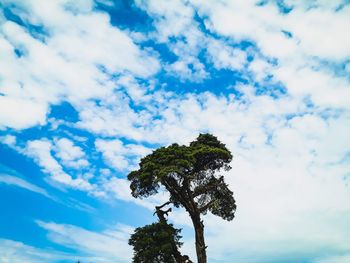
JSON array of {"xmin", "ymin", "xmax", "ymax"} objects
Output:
[{"xmin": 0, "ymin": 0, "xmax": 350, "ymax": 263}]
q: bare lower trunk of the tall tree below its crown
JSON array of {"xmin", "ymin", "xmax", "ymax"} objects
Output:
[{"xmin": 191, "ymin": 214, "xmax": 207, "ymax": 263}]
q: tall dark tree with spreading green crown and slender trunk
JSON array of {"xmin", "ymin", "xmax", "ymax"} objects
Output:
[{"xmin": 128, "ymin": 134, "xmax": 236, "ymax": 263}]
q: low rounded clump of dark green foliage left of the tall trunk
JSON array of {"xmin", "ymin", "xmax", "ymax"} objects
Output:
[{"xmin": 129, "ymin": 222, "xmax": 182, "ymax": 263}]
